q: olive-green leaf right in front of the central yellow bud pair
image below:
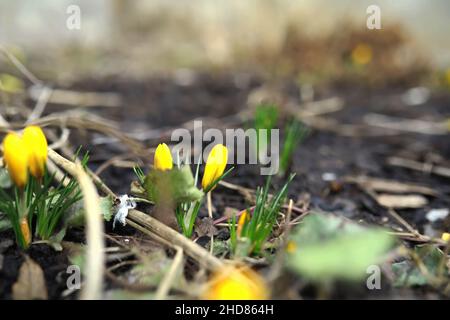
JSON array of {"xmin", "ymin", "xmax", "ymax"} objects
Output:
[{"xmin": 145, "ymin": 165, "xmax": 203, "ymax": 205}]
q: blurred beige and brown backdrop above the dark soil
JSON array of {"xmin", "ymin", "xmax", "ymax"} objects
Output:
[{"xmin": 0, "ymin": 0, "xmax": 450, "ymax": 84}]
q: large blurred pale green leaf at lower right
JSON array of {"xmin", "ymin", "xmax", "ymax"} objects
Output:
[{"xmin": 287, "ymin": 213, "xmax": 393, "ymax": 283}]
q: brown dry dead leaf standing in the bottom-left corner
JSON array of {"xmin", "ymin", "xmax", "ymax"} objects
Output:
[{"xmin": 12, "ymin": 256, "xmax": 48, "ymax": 300}]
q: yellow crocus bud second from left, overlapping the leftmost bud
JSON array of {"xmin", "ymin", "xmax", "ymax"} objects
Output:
[{"xmin": 23, "ymin": 126, "xmax": 48, "ymax": 179}]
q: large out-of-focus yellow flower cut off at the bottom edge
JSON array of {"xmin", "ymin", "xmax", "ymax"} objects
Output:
[{"xmin": 202, "ymin": 267, "xmax": 269, "ymax": 300}]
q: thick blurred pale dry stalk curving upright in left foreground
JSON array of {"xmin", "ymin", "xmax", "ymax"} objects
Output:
[{"xmin": 75, "ymin": 164, "xmax": 105, "ymax": 300}]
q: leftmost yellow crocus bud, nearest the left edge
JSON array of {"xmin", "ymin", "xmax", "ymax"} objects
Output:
[{"xmin": 3, "ymin": 132, "xmax": 28, "ymax": 188}]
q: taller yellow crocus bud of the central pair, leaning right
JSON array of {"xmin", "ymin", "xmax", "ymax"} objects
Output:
[{"xmin": 202, "ymin": 144, "xmax": 228, "ymax": 190}]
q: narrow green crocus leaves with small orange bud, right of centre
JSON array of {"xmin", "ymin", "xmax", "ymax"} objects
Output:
[{"xmin": 229, "ymin": 174, "xmax": 295, "ymax": 256}]
